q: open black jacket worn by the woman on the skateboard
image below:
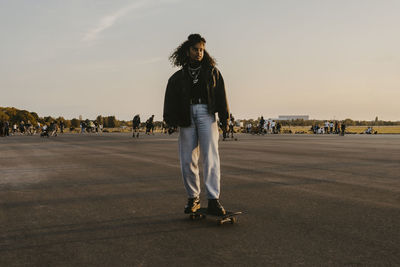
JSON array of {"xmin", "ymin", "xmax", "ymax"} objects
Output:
[{"xmin": 164, "ymin": 67, "xmax": 229, "ymax": 127}]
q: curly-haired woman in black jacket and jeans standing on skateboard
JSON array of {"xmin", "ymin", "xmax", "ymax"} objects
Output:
[{"xmin": 164, "ymin": 34, "xmax": 229, "ymax": 215}]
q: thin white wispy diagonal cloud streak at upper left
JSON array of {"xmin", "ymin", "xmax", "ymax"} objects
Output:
[{"xmin": 82, "ymin": 1, "xmax": 149, "ymax": 43}]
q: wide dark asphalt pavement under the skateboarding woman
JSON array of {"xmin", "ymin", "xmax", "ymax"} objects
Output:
[{"xmin": 0, "ymin": 133, "xmax": 400, "ymax": 266}]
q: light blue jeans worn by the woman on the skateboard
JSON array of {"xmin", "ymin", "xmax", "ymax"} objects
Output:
[{"xmin": 179, "ymin": 104, "xmax": 221, "ymax": 199}]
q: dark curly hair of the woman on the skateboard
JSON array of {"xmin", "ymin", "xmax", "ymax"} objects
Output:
[{"xmin": 169, "ymin": 33, "xmax": 216, "ymax": 67}]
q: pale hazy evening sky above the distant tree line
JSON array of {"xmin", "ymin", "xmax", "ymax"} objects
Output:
[{"xmin": 0, "ymin": 0, "xmax": 400, "ymax": 121}]
